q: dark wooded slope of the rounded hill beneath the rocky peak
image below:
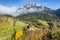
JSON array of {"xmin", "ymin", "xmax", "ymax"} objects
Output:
[{"xmin": 17, "ymin": 12, "xmax": 57, "ymax": 21}]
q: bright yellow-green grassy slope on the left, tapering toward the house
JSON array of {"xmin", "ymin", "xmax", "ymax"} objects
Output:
[{"xmin": 0, "ymin": 16, "xmax": 27, "ymax": 38}]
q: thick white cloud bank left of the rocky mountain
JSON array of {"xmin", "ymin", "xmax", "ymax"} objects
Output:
[{"xmin": 0, "ymin": 4, "xmax": 17, "ymax": 16}]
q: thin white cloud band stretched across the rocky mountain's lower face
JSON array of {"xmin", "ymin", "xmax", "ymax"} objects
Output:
[{"xmin": 17, "ymin": 8, "xmax": 44, "ymax": 15}]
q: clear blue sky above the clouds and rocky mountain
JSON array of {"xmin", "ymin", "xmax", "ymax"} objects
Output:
[{"xmin": 0, "ymin": 0, "xmax": 60, "ymax": 9}]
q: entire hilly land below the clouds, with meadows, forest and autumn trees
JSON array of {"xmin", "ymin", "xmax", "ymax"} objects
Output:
[{"xmin": 0, "ymin": 12, "xmax": 60, "ymax": 40}]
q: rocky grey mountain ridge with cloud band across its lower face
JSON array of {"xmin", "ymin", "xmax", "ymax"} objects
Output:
[{"xmin": 17, "ymin": 3, "xmax": 54, "ymax": 13}]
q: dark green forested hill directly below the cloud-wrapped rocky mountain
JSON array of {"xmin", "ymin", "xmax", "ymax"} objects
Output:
[{"xmin": 17, "ymin": 12, "xmax": 59, "ymax": 26}]
